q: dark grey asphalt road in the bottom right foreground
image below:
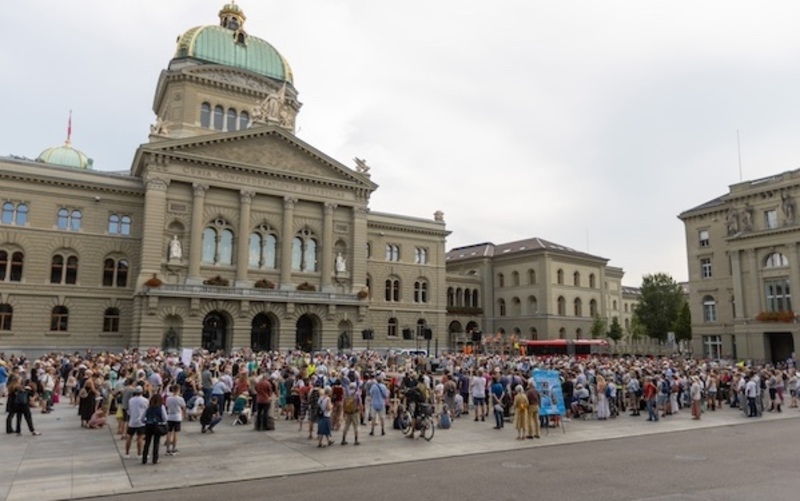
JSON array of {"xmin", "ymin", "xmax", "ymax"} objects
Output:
[{"xmin": 90, "ymin": 419, "xmax": 800, "ymax": 501}]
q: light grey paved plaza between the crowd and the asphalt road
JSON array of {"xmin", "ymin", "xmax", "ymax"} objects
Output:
[{"xmin": 0, "ymin": 398, "xmax": 800, "ymax": 501}]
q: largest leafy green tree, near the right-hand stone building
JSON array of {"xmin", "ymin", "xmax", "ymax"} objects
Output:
[{"xmin": 633, "ymin": 273, "xmax": 685, "ymax": 341}]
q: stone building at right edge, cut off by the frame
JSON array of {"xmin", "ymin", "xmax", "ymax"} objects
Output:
[{"xmin": 678, "ymin": 170, "xmax": 800, "ymax": 362}]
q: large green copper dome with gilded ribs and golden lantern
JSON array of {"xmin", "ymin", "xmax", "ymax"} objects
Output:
[{"xmin": 175, "ymin": 4, "xmax": 294, "ymax": 83}]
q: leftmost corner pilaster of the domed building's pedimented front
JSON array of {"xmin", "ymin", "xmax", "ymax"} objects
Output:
[{"xmin": 139, "ymin": 177, "xmax": 169, "ymax": 281}]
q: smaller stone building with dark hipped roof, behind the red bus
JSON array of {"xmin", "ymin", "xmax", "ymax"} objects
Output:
[{"xmin": 446, "ymin": 238, "xmax": 635, "ymax": 346}]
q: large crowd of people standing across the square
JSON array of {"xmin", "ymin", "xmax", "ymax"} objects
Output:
[{"xmin": 0, "ymin": 349, "xmax": 798, "ymax": 456}]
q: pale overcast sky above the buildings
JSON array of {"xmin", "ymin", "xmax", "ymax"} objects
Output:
[{"xmin": 0, "ymin": 0, "xmax": 800, "ymax": 286}]
